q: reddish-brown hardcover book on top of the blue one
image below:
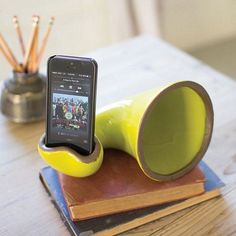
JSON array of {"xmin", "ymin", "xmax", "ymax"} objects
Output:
[{"xmin": 58, "ymin": 149, "xmax": 204, "ymax": 220}]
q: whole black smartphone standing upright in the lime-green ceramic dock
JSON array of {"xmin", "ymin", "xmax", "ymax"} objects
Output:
[{"xmin": 45, "ymin": 55, "xmax": 97, "ymax": 155}]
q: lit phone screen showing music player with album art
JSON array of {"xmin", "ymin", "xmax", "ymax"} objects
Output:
[{"xmin": 50, "ymin": 71, "xmax": 91, "ymax": 148}]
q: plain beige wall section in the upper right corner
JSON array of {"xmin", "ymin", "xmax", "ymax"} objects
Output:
[{"xmin": 161, "ymin": 0, "xmax": 236, "ymax": 49}]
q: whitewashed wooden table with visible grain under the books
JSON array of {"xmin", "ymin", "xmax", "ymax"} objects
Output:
[{"xmin": 0, "ymin": 37, "xmax": 236, "ymax": 235}]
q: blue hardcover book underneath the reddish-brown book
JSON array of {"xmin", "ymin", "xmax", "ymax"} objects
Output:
[{"xmin": 40, "ymin": 149, "xmax": 224, "ymax": 235}]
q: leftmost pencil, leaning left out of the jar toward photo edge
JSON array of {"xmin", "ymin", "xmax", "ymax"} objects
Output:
[{"xmin": 0, "ymin": 33, "xmax": 22, "ymax": 71}]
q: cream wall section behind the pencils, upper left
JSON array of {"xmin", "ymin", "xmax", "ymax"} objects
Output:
[{"xmin": 0, "ymin": 0, "xmax": 134, "ymax": 79}]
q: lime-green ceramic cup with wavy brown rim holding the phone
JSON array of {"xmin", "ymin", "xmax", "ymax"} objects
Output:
[{"xmin": 38, "ymin": 135, "xmax": 103, "ymax": 177}]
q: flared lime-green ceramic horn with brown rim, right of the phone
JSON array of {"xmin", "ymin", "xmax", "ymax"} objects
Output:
[{"xmin": 96, "ymin": 81, "xmax": 213, "ymax": 181}]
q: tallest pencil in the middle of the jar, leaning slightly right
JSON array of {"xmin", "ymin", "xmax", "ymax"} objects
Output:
[{"xmin": 23, "ymin": 16, "xmax": 39, "ymax": 71}]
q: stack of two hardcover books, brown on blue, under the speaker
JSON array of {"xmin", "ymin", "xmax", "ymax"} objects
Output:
[{"xmin": 40, "ymin": 149, "xmax": 224, "ymax": 235}]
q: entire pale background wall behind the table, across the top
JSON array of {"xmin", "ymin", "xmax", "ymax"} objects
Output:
[{"xmin": 0, "ymin": 0, "xmax": 236, "ymax": 79}]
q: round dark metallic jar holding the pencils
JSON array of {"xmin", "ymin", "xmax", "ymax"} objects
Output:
[{"xmin": 1, "ymin": 72, "xmax": 46, "ymax": 123}]
